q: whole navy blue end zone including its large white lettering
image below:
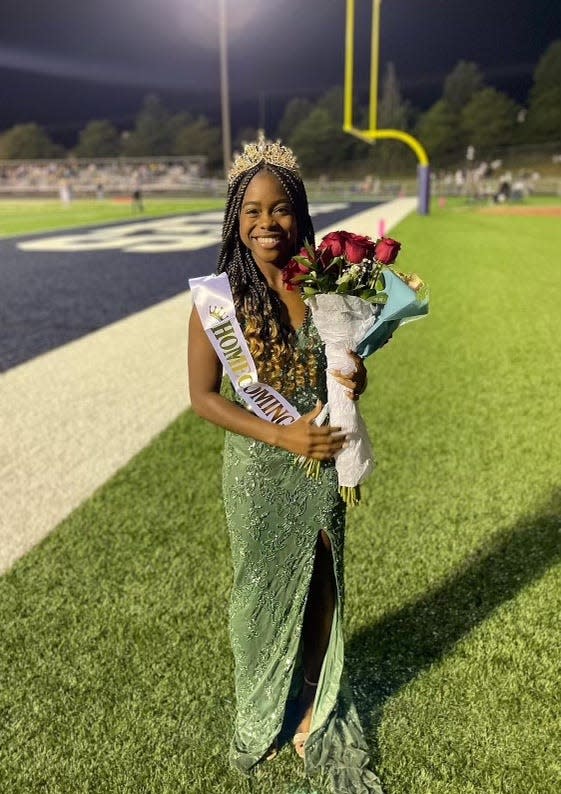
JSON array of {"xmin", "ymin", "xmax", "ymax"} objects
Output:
[{"xmin": 0, "ymin": 202, "xmax": 375, "ymax": 372}]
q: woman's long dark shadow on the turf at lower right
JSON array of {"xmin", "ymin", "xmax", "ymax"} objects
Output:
[{"xmin": 346, "ymin": 482, "xmax": 561, "ymax": 760}]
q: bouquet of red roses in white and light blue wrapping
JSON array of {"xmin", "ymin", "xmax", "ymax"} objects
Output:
[{"xmin": 283, "ymin": 231, "xmax": 428, "ymax": 504}]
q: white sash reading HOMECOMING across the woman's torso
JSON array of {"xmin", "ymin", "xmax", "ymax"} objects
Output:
[{"xmin": 189, "ymin": 273, "xmax": 300, "ymax": 425}]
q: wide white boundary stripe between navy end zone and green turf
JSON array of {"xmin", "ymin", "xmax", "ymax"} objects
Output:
[{"xmin": 0, "ymin": 199, "xmax": 416, "ymax": 573}]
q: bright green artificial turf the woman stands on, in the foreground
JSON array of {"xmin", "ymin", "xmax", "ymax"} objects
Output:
[{"xmin": 0, "ymin": 204, "xmax": 561, "ymax": 794}]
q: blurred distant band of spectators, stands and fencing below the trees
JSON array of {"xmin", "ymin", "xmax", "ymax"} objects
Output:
[{"xmin": 0, "ymin": 148, "xmax": 561, "ymax": 201}]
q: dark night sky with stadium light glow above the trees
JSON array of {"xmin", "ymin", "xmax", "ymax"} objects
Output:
[{"xmin": 0, "ymin": 0, "xmax": 561, "ymax": 144}]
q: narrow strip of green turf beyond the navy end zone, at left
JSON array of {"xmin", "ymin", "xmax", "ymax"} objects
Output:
[{"xmin": 0, "ymin": 198, "xmax": 224, "ymax": 237}]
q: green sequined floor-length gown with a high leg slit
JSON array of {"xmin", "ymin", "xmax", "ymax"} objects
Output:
[{"xmin": 223, "ymin": 313, "xmax": 382, "ymax": 794}]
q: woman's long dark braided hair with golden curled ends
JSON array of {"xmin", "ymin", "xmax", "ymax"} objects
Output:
[{"xmin": 217, "ymin": 161, "xmax": 316, "ymax": 396}]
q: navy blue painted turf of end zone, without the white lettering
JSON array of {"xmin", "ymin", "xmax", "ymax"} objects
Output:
[{"xmin": 0, "ymin": 203, "xmax": 373, "ymax": 372}]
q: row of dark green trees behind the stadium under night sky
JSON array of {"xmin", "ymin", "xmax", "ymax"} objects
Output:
[{"xmin": 0, "ymin": 40, "xmax": 561, "ymax": 175}]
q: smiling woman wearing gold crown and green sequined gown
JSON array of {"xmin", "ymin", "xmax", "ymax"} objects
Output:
[{"xmin": 189, "ymin": 140, "xmax": 381, "ymax": 794}]
